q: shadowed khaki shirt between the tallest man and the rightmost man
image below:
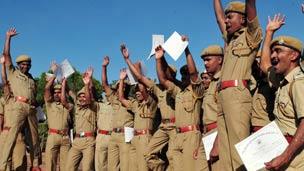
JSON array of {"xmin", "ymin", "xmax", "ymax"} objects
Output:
[{"xmin": 251, "ymin": 79, "xmax": 275, "ymax": 126}]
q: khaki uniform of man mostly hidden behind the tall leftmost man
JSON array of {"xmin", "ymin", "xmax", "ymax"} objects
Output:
[{"xmin": 0, "ymin": 97, "xmax": 27, "ymax": 171}]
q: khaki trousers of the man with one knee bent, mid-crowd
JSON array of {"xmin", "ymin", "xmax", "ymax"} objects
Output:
[{"xmin": 145, "ymin": 127, "xmax": 181, "ymax": 171}]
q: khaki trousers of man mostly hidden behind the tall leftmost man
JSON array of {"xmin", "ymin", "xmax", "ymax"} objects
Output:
[{"xmin": 0, "ymin": 131, "xmax": 27, "ymax": 171}]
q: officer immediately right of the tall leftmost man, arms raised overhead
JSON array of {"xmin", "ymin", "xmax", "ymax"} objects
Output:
[{"xmin": 44, "ymin": 64, "xmax": 73, "ymax": 171}]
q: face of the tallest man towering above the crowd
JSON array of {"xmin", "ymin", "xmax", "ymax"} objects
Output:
[{"xmin": 225, "ymin": 12, "xmax": 245, "ymax": 35}]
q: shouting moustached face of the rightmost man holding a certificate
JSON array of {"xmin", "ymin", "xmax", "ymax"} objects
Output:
[{"xmin": 271, "ymin": 45, "xmax": 294, "ymax": 75}]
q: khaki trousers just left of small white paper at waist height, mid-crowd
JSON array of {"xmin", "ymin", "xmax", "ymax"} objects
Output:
[{"xmin": 108, "ymin": 132, "xmax": 131, "ymax": 171}]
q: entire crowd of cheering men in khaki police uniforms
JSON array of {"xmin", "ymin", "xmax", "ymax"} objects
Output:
[{"xmin": 0, "ymin": 0, "xmax": 304, "ymax": 171}]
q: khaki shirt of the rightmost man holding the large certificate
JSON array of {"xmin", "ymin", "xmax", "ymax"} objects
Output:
[{"xmin": 273, "ymin": 67, "xmax": 304, "ymax": 136}]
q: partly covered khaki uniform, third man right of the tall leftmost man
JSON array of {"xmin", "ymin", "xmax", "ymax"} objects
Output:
[{"xmin": 95, "ymin": 102, "xmax": 114, "ymax": 171}]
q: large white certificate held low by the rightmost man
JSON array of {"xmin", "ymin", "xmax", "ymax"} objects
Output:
[{"xmin": 235, "ymin": 121, "xmax": 288, "ymax": 171}]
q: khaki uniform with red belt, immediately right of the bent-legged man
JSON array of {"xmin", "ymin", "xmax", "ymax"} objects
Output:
[{"xmin": 168, "ymin": 80, "xmax": 208, "ymax": 171}]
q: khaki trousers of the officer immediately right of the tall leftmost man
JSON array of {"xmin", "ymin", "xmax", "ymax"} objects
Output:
[{"xmin": 45, "ymin": 133, "xmax": 71, "ymax": 171}]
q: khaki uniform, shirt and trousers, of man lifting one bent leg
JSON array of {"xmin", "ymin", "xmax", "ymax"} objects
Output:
[{"xmin": 145, "ymin": 82, "xmax": 181, "ymax": 170}]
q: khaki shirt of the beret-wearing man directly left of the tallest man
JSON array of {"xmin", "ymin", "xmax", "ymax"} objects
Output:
[{"xmin": 202, "ymin": 71, "xmax": 221, "ymax": 125}]
